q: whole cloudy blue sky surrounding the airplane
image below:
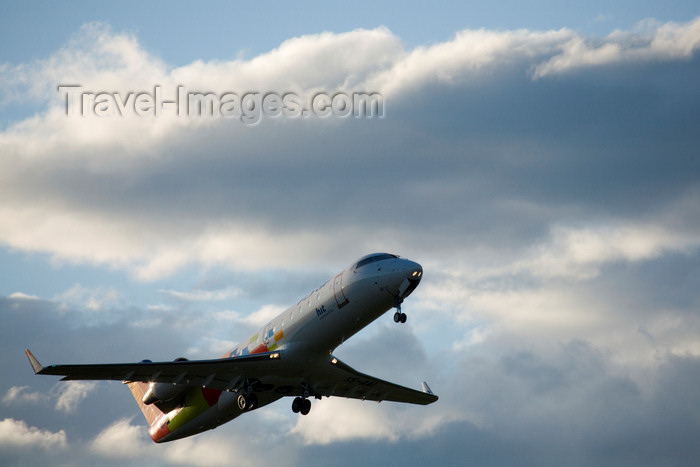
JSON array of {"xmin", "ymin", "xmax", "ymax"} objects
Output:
[{"xmin": 0, "ymin": 1, "xmax": 700, "ymax": 466}]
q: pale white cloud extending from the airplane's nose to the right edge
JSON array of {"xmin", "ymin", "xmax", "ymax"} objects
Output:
[{"xmin": 410, "ymin": 216, "xmax": 700, "ymax": 369}]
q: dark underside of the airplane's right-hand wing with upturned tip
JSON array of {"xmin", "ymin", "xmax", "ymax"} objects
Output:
[{"xmin": 312, "ymin": 357, "xmax": 438, "ymax": 405}]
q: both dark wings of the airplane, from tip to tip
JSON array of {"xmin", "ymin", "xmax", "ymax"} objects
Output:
[{"xmin": 26, "ymin": 350, "xmax": 438, "ymax": 405}]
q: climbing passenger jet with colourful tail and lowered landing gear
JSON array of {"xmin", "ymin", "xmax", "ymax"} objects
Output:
[{"xmin": 26, "ymin": 253, "xmax": 438, "ymax": 443}]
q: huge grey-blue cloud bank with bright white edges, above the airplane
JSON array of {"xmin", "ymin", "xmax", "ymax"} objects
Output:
[{"xmin": 3, "ymin": 21, "xmax": 700, "ymax": 277}]
